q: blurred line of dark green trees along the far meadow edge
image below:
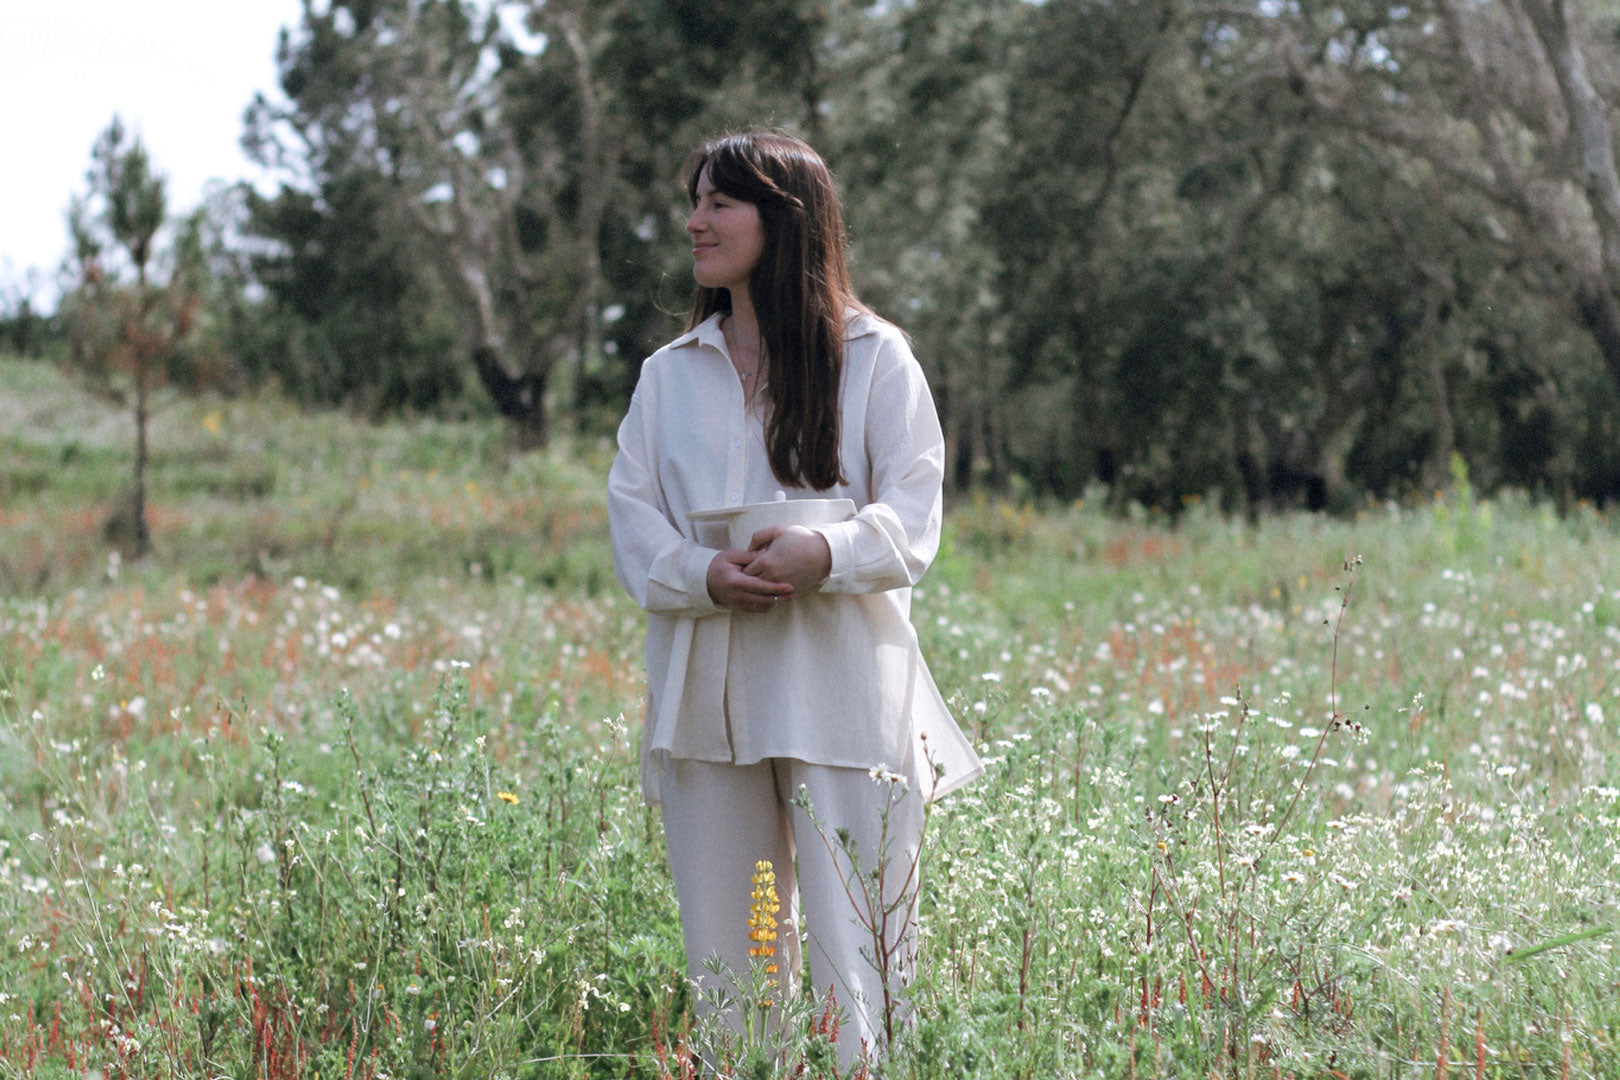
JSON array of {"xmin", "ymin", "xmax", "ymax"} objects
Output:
[{"xmin": 3, "ymin": 0, "xmax": 1620, "ymax": 512}]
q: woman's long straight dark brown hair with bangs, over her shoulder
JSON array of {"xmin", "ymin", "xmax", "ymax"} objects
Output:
[{"xmin": 684, "ymin": 131, "xmax": 867, "ymax": 491}]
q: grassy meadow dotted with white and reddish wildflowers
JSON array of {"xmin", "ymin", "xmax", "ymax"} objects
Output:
[{"xmin": 0, "ymin": 361, "xmax": 1620, "ymax": 1080}]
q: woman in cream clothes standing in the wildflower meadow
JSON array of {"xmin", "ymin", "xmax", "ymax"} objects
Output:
[{"xmin": 608, "ymin": 133, "xmax": 982, "ymax": 1061}]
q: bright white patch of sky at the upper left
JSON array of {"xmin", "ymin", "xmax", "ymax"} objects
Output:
[{"xmin": 0, "ymin": 0, "xmax": 301, "ymax": 303}]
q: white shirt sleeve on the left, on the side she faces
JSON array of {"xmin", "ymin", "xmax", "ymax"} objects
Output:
[{"xmin": 608, "ymin": 387, "xmax": 723, "ymax": 615}]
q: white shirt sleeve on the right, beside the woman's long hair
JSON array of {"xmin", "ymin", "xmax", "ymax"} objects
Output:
[{"xmin": 816, "ymin": 337, "xmax": 944, "ymax": 593}]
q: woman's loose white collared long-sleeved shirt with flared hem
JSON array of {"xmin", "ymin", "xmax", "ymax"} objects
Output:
[{"xmin": 608, "ymin": 313, "xmax": 983, "ymax": 805}]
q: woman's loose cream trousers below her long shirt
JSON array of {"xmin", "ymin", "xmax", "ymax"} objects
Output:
[{"xmin": 663, "ymin": 758, "xmax": 923, "ymax": 1064}]
